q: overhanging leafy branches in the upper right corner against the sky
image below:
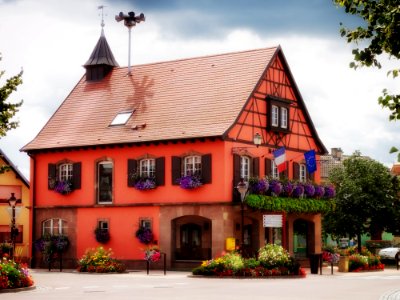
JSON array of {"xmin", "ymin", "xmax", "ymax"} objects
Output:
[{"xmin": 333, "ymin": 0, "xmax": 400, "ymax": 161}]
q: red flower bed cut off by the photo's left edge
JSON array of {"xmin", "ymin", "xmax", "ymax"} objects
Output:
[{"xmin": 0, "ymin": 257, "xmax": 33, "ymax": 290}]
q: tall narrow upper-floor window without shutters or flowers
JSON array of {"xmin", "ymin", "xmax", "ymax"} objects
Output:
[{"xmin": 97, "ymin": 161, "xmax": 114, "ymax": 203}]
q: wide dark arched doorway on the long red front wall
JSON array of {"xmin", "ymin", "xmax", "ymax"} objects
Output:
[{"xmin": 171, "ymin": 216, "xmax": 212, "ymax": 261}]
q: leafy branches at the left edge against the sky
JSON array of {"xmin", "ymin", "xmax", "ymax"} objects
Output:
[{"xmin": 0, "ymin": 54, "xmax": 23, "ymax": 174}]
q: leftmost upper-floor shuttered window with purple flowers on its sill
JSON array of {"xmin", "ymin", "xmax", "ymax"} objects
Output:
[{"xmin": 47, "ymin": 160, "xmax": 82, "ymax": 194}]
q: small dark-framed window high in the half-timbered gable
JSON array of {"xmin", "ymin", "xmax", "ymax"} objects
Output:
[{"xmin": 267, "ymin": 97, "xmax": 290, "ymax": 132}]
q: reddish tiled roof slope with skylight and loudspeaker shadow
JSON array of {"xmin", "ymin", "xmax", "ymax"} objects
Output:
[{"xmin": 22, "ymin": 47, "xmax": 280, "ymax": 151}]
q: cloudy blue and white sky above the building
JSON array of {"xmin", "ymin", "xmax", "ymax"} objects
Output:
[{"xmin": 0, "ymin": 0, "xmax": 400, "ymax": 177}]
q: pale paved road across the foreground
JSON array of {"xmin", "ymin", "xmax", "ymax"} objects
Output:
[{"xmin": 0, "ymin": 268, "xmax": 400, "ymax": 300}]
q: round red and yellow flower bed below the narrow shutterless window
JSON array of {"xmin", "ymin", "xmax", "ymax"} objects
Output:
[{"xmin": 77, "ymin": 247, "xmax": 126, "ymax": 273}]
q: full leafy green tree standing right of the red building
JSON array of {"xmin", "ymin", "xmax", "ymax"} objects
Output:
[{"xmin": 324, "ymin": 152, "xmax": 400, "ymax": 250}]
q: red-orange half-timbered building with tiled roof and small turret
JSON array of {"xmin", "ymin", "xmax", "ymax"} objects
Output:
[{"xmin": 23, "ymin": 29, "xmax": 327, "ymax": 268}]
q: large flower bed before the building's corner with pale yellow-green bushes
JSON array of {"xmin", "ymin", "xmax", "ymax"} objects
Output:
[{"xmin": 192, "ymin": 244, "xmax": 306, "ymax": 278}]
